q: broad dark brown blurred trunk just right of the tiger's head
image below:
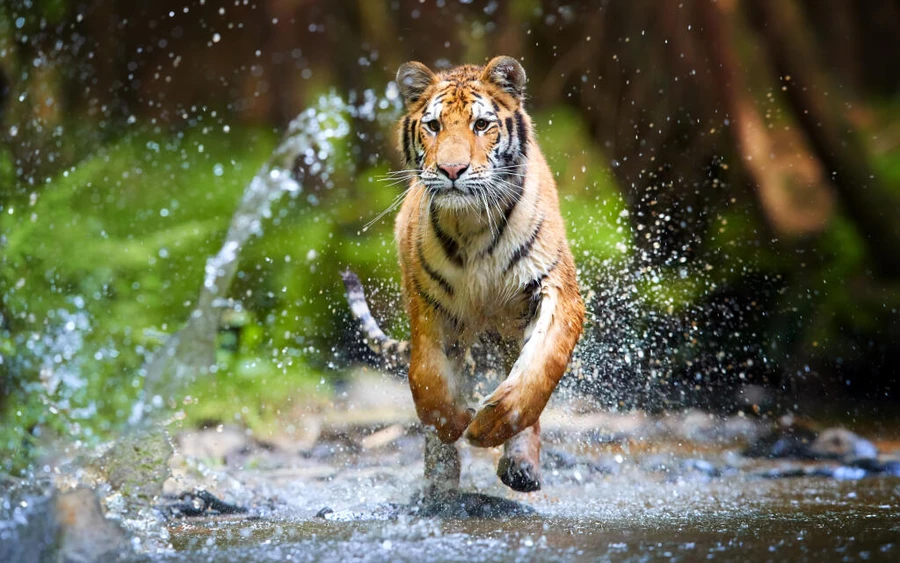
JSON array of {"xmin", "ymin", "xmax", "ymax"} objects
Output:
[{"xmin": 526, "ymin": 0, "xmax": 728, "ymax": 265}]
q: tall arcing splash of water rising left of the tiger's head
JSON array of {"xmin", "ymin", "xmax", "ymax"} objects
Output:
[{"xmin": 129, "ymin": 89, "xmax": 399, "ymax": 425}]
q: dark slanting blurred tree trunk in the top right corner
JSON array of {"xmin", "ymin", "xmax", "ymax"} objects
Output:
[{"xmin": 745, "ymin": 0, "xmax": 900, "ymax": 277}]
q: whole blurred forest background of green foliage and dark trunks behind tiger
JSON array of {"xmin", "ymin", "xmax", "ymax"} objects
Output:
[{"xmin": 0, "ymin": 0, "xmax": 900, "ymax": 470}]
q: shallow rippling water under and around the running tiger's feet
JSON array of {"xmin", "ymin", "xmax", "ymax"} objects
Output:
[{"xmin": 144, "ymin": 406, "xmax": 900, "ymax": 563}]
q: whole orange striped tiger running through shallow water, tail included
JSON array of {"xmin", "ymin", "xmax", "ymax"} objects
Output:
[{"xmin": 344, "ymin": 56, "xmax": 585, "ymax": 492}]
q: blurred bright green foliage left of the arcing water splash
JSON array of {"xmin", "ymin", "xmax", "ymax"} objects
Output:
[{"xmin": 0, "ymin": 124, "xmax": 286, "ymax": 469}]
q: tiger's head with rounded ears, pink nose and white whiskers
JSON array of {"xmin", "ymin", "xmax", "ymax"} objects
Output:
[{"xmin": 397, "ymin": 57, "xmax": 531, "ymax": 209}]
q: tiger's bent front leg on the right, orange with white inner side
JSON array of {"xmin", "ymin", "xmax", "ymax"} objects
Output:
[{"xmin": 466, "ymin": 276, "xmax": 584, "ymax": 451}]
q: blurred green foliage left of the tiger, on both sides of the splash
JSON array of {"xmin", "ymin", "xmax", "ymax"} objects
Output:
[{"xmin": 0, "ymin": 108, "xmax": 408, "ymax": 470}]
